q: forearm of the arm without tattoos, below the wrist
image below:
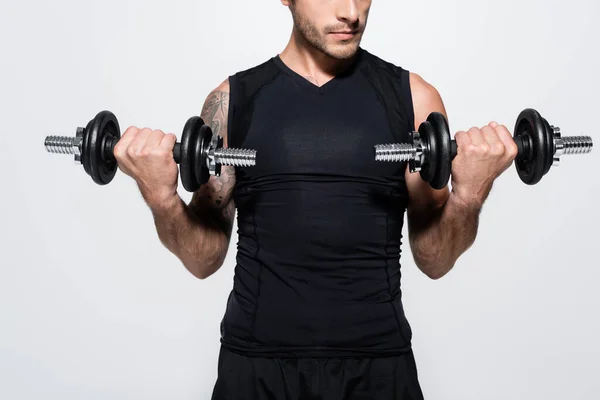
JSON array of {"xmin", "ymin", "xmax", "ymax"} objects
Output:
[{"xmin": 410, "ymin": 192, "xmax": 481, "ymax": 279}]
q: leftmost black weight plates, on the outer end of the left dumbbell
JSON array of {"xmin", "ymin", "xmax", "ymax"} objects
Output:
[{"xmin": 81, "ymin": 110, "xmax": 121, "ymax": 185}]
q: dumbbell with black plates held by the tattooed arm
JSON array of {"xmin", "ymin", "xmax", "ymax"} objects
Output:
[{"xmin": 44, "ymin": 110, "xmax": 256, "ymax": 192}]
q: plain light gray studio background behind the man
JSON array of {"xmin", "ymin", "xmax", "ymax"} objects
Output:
[{"xmin": 0, "ymin": 0, "xmax": 600, "ymax": 400}]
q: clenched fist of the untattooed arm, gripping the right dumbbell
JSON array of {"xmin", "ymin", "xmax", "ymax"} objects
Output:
[{"xmin": 452, "ymin": 122, "xmax": 518, "ymax": 205}]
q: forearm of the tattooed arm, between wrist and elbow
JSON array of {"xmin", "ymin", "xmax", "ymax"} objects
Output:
[{"xmin": 150, "ymin": 196, "xmax": 228, "ymax": 279}]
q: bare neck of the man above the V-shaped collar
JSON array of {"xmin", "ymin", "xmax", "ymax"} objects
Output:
[{"xmin": 279, "ymin": 28, "xmax": 358, "ymax": 85}]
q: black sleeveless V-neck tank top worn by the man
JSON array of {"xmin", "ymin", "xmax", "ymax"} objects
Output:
[{"xmin": 221, "ymin": 48, "xmax": 414, "ymax": 357}]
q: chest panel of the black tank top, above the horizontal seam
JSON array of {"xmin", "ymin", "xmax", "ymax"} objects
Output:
[{"xmin": 237, "ymin": 78, "xmax": 404, "ymax": 177}]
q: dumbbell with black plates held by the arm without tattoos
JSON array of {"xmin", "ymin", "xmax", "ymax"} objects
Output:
[{"xmin": 375, "ymin": 108, "xmax": 593, "ymax": 189}]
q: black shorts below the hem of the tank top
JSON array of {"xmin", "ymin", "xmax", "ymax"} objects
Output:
[{"xmin": 212, "ymin": 347, "xmax": 423, "ymax": 400}]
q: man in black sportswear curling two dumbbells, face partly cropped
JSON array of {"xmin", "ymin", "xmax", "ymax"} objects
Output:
[{"xmin": 115, "ymin": 0, "xmax": 517, "ymax": 400}]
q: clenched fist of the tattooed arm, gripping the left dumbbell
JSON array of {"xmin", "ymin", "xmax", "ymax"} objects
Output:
[{"xmin": 114, "ymin": 126, "xmax": 178, "ymax": 208}]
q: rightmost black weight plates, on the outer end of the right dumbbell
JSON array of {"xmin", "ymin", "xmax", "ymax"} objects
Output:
[{"xmin": 513, "ymin": 108, "xmax": 554, "ymax": 185}]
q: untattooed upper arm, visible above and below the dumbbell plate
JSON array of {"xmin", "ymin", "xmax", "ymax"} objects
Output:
[{"xmin": 405, "ymin": 73, "xmax": 450, "ymax": 229}]
